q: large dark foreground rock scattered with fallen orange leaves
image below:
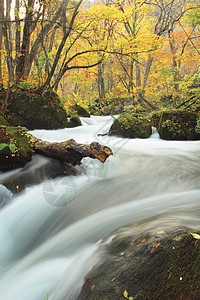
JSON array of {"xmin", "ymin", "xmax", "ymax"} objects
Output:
[{"xmin": 78, "ymin": 230, "xmax": 200, "ymax": 300}]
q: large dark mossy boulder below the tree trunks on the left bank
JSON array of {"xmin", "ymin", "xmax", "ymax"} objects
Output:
[{"xmin": 0, "ymin": 89, "xmax": 70, "ymax": 129}]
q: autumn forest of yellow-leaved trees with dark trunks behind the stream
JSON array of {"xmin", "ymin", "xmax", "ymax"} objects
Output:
[{"xmin": 0, "ymin": 0, "xmax": 200, "ymax": 113}]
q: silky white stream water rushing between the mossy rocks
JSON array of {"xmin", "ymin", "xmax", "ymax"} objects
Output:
[{"xmin": 0, "ymin": 117, "xmax": 200, "ymax": 300}]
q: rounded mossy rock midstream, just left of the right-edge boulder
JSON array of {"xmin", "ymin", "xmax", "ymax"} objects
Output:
[{"xmin": 110, "ymin": 113, "xmax": 152, "ymax": 138}]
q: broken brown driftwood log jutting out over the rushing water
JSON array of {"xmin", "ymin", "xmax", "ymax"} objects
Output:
[{"xmin": 32, "ymin": 136, "xmax": 113, "ymax": 166}]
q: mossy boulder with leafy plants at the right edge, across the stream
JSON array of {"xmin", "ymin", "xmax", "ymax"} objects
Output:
[{"xmin": 151, "ymin": 110, "xmax": 200, "ymax": 140}]
